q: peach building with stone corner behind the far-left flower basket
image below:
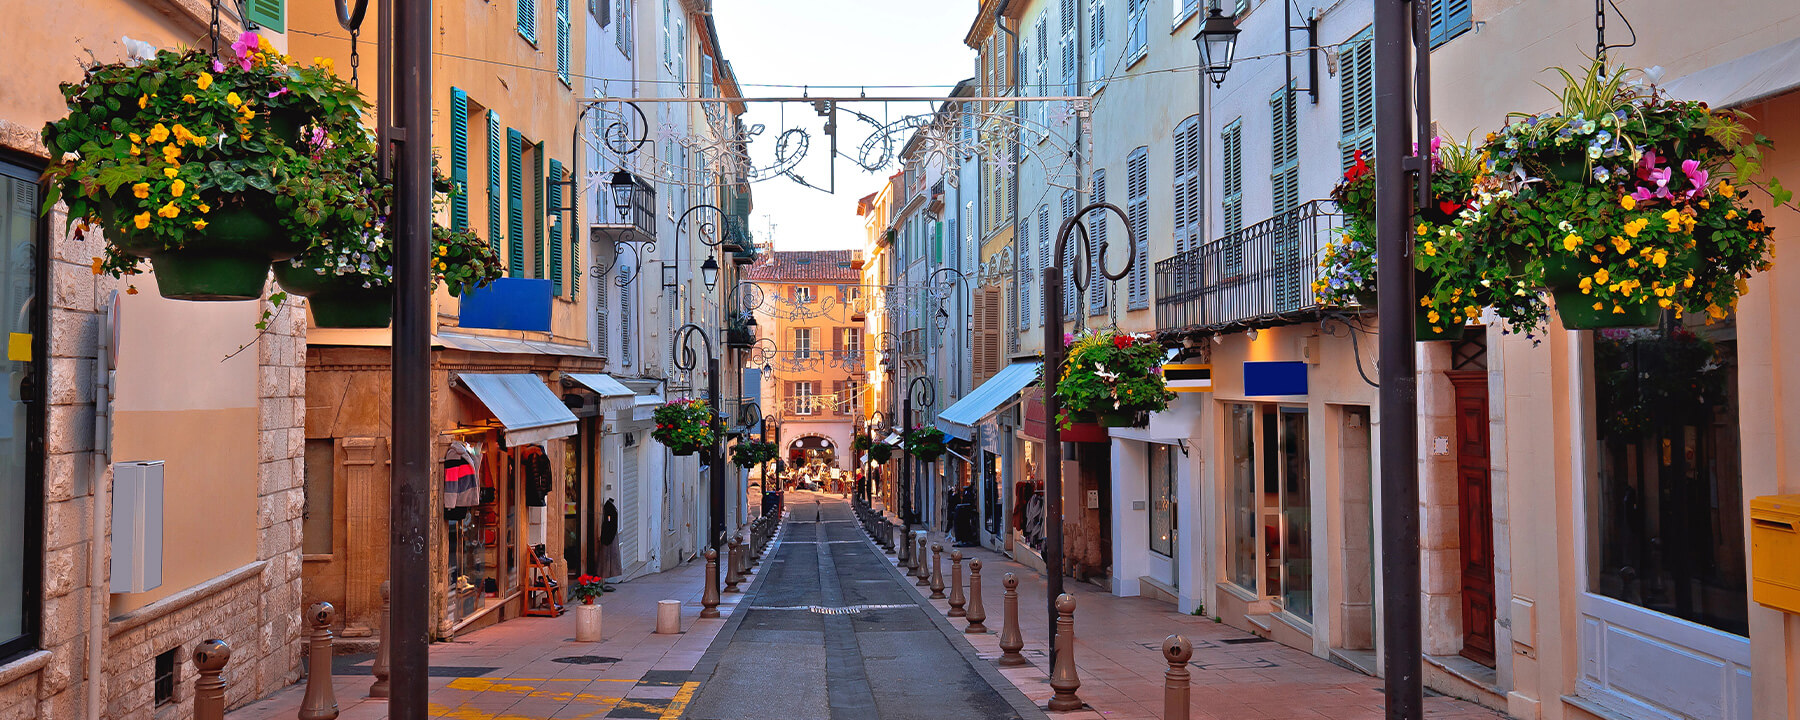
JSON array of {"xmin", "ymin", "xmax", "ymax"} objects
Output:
[{"xmin": 0, "ymin": 0, "xmax": 306, "ymax": 718}]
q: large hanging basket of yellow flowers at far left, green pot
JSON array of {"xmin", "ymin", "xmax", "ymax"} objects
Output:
[{"xmin": 43, "ymin": 32, "xmax": 371, "ymax": 301}]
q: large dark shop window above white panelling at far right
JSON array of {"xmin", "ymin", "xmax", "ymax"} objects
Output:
[{"xmin": 1586, "ymin": 319, "xmax": 1750, "ymax": 635}]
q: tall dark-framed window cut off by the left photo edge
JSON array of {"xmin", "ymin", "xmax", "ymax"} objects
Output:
[{"xmin": 0, "ymin": 162, "xmax": 45, "ymax": 662}]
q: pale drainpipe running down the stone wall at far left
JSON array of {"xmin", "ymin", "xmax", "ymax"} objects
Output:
[{"xmin": 86, "ymin": 290, "xmax": 119, "ymax": 718}]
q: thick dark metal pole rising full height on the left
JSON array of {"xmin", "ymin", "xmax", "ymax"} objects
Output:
[{"xmin": 382, "ymin": 0, "xmax": 432, "ymax": 720}]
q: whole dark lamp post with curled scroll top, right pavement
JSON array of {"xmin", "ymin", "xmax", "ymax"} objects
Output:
[{"xmin": 1044, "ymin": 202, "xmax": 1138, "ymax": 662}]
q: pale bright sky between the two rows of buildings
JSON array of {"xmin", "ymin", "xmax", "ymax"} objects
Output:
[{"xmin": 713, "ymin": 0, "xmax": 977, "ymax": 250}]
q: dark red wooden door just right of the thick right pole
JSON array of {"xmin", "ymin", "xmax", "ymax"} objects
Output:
[{"xmin": 1447, "ymin": 371, "xmax": 1494, "ymax": 666}]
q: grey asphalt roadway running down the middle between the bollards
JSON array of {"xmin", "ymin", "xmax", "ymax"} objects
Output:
[{"xmin": 684, "ymin": 493, "xmax": 1044, "ymax": 720}]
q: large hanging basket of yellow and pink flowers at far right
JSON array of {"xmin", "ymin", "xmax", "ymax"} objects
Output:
[{"xmin": 1444, "ymin": 63, "xmax": 1791, "ymax": 331}]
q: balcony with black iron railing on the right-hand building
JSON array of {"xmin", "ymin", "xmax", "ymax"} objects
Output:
[{"xmin": 1156, "ymin": 200, "xmax": 1341, "ymax": 331}]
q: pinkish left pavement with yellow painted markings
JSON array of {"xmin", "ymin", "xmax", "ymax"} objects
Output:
[{"xmin": 225, "ymin": 536, "xmax": 745, "ymax": 720}]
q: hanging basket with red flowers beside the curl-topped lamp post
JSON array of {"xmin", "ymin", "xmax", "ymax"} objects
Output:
[{"xmin": 1057, "ymin": 328, "xmax": 1175, "ymax": 430}]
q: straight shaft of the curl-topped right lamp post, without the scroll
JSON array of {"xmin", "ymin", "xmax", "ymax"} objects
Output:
[{"xmin": 1044, "ymin": 262, "xmax": 1062, "ymax": 658}]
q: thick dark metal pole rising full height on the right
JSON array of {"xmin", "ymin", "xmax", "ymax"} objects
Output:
[{"xmin": 1375, "ymin": 0, "xmax": 1424, "ymax": 720}]
